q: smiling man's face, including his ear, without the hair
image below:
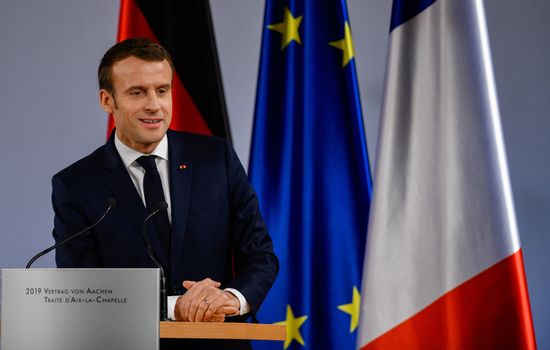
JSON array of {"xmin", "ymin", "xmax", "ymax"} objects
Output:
[{"xmin": 99, "ymin": 56, "xmax": 172, "ymax": 153}]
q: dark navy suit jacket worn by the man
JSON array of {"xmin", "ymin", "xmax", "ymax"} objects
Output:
[{"xmin": 52, "ymin": 131, "xmax": 278, "ymax": 346}]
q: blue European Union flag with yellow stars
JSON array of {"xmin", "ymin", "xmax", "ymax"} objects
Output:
[{"xmin": 249, "ymin": 0, "xmax": 371, "ymax": 349}]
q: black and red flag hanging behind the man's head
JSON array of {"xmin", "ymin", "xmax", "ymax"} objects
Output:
[{"xmin": 108, "ymin": 0, "xmax": 231, "ymax": 140}]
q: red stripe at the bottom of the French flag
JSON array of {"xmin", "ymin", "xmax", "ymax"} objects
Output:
[{"xmin": 361, "ymin": 250, "xmax": 536, "ymax": 350}]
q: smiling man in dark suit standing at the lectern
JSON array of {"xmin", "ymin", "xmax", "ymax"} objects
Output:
[{"xmin": 52, "ymin": 39, "xmax": 278, "ymax": 348}]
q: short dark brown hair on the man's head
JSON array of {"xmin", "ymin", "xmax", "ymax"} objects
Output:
[{"xmin": 97, "ymin": 38, "xmax": 174, "ymax": 96}]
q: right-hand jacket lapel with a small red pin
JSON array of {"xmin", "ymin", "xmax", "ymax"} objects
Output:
[{"xmin": 168, "ymin": 131, "xmax": 193, "ymax": 269}]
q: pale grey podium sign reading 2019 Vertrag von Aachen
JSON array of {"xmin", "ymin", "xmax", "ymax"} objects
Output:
[{"xmin": 0, "ymin": 269, "xmax": 160, "ymax": 350}]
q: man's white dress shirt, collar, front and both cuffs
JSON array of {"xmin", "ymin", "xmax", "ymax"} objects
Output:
[{"xmin": 115, "ymin": 133, "xmax": 250, "ymax": 320}]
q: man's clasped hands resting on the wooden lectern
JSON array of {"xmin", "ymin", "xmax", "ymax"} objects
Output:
[{"xmin": 174, "ymin": 278, "xmax": 240, "ymax": 322}]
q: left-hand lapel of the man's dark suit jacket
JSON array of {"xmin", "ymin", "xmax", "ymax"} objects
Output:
[{"xmin": 104, "ymin": 132, "xmax": 169, "ymax": 266}]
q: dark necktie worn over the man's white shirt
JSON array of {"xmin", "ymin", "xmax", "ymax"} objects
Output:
[{"xmin": 136, "ymin": 156, "xmax": 172, "ymax": 260}]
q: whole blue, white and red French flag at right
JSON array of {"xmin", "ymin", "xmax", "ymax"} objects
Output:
[{"xmin": 358, "ymin": 0, "xmax": 536, "ymax": 350}]
